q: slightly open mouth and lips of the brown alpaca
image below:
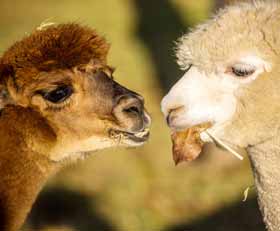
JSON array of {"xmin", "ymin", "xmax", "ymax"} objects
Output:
[{"xmin": 109, "ymin": 128, "xmax": 150, "ymax": 143}]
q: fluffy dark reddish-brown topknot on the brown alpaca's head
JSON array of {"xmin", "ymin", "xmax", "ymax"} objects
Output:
[{"xmin": 0, "ymin": 23, "xmax": 109, "ymax": 88}]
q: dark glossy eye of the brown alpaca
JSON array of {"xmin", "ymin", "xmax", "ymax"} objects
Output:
[{"xmin": 43, "ymin": 86, "xmax": 73, "ymax": 103}]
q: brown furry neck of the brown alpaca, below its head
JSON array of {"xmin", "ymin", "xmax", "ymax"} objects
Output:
[{"xmin": 0, "ymin": 106, "xmax": 58, "ymax": 231}]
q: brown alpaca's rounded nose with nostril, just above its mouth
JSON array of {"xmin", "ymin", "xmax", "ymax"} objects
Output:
[{"xmin": 113, "ymin": 93, "xmax": 151, "ymax": 133}]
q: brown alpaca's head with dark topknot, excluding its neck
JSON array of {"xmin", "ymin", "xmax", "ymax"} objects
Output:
[{"xmin": 0, "ymin": 24, "xmax": 150, "ymax": 161}]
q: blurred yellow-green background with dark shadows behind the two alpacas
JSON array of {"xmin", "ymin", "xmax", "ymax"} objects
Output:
[{"xmin": 0, "ymin": 0, "xmax": 264, "ymax": 231}]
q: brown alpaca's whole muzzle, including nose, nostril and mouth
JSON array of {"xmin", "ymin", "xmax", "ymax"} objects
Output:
[{"xmin": 111, "ymin": 92, "xmax": 151, "ymax": 143}]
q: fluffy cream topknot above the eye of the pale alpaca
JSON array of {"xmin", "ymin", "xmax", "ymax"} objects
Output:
[{"xmin": 176, "ymin": 0, "xmax": 280, "ymax": 72}]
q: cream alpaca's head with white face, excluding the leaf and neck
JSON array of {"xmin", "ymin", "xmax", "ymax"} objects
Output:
[{"xmin": 162, "ymin": 1, "xmax": 280, "ymax": 148}]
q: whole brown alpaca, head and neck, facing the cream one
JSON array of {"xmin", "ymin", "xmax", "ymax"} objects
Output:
[{"xmin": 0, "ymin": 24, "xmax": 150, "ymax": 231}]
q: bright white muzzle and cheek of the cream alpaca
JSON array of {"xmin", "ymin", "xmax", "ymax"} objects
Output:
[{"xmin": 162, "ymin": 67, "xmax": 236, "ymax": 128}]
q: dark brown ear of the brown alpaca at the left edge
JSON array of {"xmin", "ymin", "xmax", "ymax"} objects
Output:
[{"xmin": 0, "ymin": 64, "xmax": 15, "ymax": 110}]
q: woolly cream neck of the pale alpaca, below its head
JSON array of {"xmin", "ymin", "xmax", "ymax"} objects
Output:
[{"xmin": 248, "ymin": 134, "xmax": 280, "ymax": 231}]
